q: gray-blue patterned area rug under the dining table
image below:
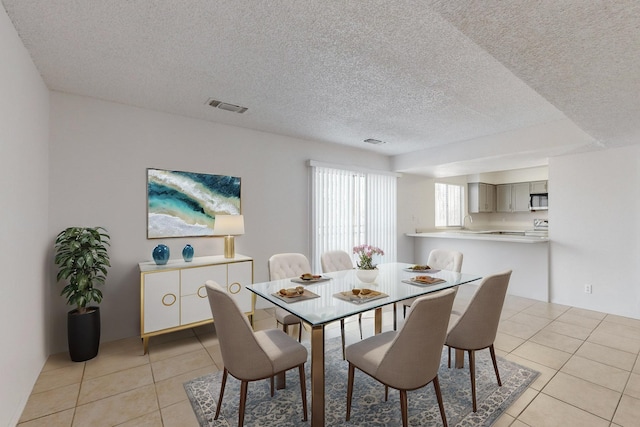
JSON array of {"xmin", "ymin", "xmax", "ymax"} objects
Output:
[{"xmin": 184, "ymin": 339, "xmax": 538, "ymax": 427}]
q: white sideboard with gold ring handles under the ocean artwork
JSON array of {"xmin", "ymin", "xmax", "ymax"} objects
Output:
[{"xmin": 138, "ymin": 254, "xmax": 255, "ymax": 354}]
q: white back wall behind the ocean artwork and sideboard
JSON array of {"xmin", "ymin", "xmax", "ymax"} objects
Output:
[{"xmin": 48, "ymin": 92, "xmax": 411, "ymax": 352}]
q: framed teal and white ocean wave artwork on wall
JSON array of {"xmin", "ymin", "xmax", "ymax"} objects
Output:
[{"xmin": 147, "ymin": 169, "xmax": 241, "ymax": 239}]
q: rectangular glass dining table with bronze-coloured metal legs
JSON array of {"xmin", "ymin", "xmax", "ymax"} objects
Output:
[{"xmin": 247, "ymin": 263, "xmax": 481, "ymax": 426}]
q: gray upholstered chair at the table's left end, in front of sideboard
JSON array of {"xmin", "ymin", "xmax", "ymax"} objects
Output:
[{"xmin": 205, "ymin": 280, "xmax": 307, "ymax": 426}]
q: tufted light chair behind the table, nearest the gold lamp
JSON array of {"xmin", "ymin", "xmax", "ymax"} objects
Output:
[{"xmin": 269, "ymin": 253, "xmax": 311, "ymax": 341}]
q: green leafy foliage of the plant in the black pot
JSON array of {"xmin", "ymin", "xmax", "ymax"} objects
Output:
[{"xmin": 55, "ymin": 227, "xmax": 111, "ymax": 314}]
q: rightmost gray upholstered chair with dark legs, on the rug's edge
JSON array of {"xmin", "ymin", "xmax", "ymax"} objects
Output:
[{"xmin": 445, "ymin": 270, "xmax": 511, "ymax": 412}]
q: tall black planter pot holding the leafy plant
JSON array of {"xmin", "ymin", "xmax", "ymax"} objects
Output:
[{"xmin": 67, "ymin": 307, "xmax": 100, "ymax": 362}]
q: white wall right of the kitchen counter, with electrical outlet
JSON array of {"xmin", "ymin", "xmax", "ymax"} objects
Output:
[{"xmin": 549, "ymin": 146, "xmax": 640, "ymax": 318}]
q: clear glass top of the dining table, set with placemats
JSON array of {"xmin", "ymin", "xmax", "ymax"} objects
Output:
[{"xmin": 247, "ymin": 263, "xmax": 481, "ymax": 326}]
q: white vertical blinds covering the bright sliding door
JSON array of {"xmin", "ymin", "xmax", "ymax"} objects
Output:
[{"xmin": 311, "ymin": 162, "xmax": 397, "ymax": 272}]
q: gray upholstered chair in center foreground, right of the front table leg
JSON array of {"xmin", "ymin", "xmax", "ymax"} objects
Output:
[{"xmin": 346, "ymin": 289, "xmax": 455, "ymax": 427}]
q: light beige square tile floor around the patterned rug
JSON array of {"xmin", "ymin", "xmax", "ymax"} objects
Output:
[{"xmin": 19, "ymin": 285, "xmax": 640, "ymax": 427}]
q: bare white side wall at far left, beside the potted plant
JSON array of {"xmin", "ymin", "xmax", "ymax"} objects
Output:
[{"xmin": 0, "ymin": 7, "xmax": 50, "ymax": 426}]
